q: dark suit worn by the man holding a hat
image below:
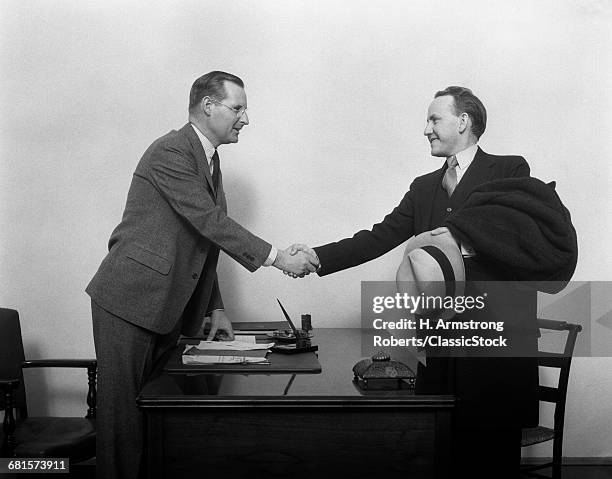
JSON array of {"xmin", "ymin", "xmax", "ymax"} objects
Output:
[{"xmin": 315, "ymin": 148, "xmax": 538, "ymax": 477}]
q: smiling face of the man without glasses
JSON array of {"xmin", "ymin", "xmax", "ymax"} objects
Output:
[{"xmin": 423, "ymin": 96, "xmax": 467, "ymax": 157}]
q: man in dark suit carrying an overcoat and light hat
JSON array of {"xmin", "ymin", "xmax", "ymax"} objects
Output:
[{"xmin": 292, "ymin": 86, "xmax": 538, "ymax": 477}]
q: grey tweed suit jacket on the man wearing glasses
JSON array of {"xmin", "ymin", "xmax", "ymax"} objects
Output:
[{"xmin": 86, "ymin": 123, "xmax": 271, "ymax": 334}]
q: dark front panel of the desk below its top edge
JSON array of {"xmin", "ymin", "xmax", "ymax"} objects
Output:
[{"xmin": 148, "ymin": 407, "xmax": 450, "ymax": 479}]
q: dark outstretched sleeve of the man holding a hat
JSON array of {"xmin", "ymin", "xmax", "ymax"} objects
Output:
[{"xmin": 315, "ymin": 188, "xmax": 414, "ymax": 276}]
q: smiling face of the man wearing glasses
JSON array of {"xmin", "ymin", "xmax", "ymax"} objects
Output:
[{"xmin": 207, "ymin": 81, "xmax": 249, "ymax": 148}]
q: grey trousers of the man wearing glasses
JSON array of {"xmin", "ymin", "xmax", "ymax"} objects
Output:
[{"xmin": 91, "ymin": 301, "xmax": 181, "ymax": 479}]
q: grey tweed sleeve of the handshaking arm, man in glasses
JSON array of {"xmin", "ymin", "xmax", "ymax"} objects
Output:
[{"xmin": 145, "ymin": 146, "xmax": 272, "ymax": 271}]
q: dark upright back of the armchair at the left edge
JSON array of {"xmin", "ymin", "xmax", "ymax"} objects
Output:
[{"xmin": 0, "ymin": 308, "xmax": 28, "ymax": 418}]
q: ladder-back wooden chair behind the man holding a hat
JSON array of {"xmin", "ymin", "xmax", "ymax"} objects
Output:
[{"xmin": 521, "ymin": 319, "xmax": 582, "ymax": 479}]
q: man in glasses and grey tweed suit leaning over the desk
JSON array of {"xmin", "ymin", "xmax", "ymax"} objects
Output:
[{"xmin": 86, "ymin": 71, "xmax": 318, "ymax": 479}]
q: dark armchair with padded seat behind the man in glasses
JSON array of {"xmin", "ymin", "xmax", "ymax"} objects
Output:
[{"xmin": 0, "ymin": 308, "xmax": 97, "ymax": 463}]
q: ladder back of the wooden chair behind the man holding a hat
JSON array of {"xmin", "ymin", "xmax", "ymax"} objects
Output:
[{"xmin": 538, "ymin": 319, "xmax": 582, "ymax": 434}]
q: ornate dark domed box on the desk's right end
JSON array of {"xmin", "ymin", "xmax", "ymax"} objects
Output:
[{"xmin": 353, "ymin": 351, "xmax": 415, "ymax": 389}]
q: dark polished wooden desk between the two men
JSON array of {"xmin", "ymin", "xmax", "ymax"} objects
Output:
[{"xmin": 137, "ymin": 329, "xmax": 455, "ymax": 479}]
